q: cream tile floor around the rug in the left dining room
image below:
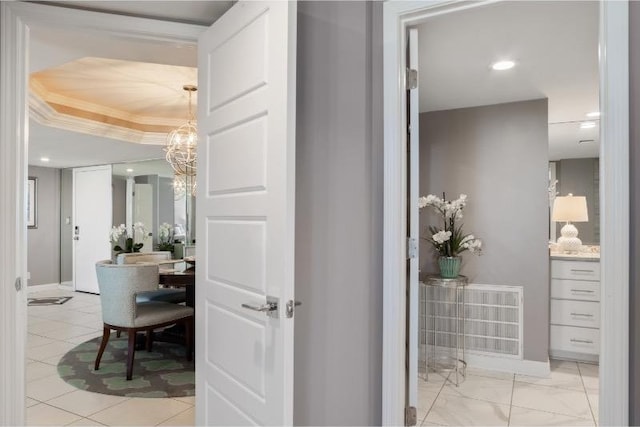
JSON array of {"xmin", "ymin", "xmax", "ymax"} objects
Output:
[{"xmin": 26, "ymin": 290, "xmax": 195, "ymax": 426}]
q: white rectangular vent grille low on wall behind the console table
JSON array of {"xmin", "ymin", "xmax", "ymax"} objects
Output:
[{"xmin": 420, "ymin": 284, "xmax": 523, "ymax": 358}]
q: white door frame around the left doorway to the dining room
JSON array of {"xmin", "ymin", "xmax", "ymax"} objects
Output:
[{"xmin": 0, "ymin": 1, "xmax": 206, "ymax": 425}]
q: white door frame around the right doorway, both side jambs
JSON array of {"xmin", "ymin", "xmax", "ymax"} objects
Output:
[{"xmin": 382, "ymin": 0, "xmax": 629, "ymax": 426}]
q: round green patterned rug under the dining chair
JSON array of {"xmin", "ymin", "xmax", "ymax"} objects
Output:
[{"xmin": 58, "ymin": 333, "xmax": 195, "ymax": 397}]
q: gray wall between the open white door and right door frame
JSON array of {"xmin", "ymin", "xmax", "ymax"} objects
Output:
[{"xmin": 294, "ymin": 2, "xmax": 382, "ymax": 425}]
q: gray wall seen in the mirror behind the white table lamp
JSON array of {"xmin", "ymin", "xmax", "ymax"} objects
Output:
[{"xmin": 556, "ymin": 158, "xmax": 600, "ymax": 245}]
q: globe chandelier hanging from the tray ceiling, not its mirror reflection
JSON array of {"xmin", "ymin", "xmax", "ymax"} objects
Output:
[{"xmin": 164, "ymin": 85, "xmax": 198, "ymax": 178}]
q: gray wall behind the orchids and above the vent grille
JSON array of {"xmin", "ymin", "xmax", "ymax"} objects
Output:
[{"xmin": 420, "ymin": 99, "xmax": 549, "ymax": 361}]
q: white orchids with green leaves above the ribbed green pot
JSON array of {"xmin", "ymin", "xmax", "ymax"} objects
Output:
[{"xmin": 418, "ymin": 193, "xmax": 482, "ymax": 257}]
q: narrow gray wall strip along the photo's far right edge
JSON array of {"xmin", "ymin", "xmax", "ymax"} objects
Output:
[{"xmin": 629, "ymin": 1, "xmax": 640, "ymax": 425}]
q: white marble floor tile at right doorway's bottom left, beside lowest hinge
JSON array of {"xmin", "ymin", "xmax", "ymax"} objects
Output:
[{"xmin": 425, "ymin": 393, "xmax": 509, "ymax": 426}]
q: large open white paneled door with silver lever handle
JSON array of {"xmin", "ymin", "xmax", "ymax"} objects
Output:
[{"xmin": 196, "ymin": 1, "xmax": 296, "ymax": 425}]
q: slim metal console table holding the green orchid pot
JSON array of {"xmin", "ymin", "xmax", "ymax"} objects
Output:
[{"xmin": 420, "ymin": 275, "xmax": 468, "ymax": 386}]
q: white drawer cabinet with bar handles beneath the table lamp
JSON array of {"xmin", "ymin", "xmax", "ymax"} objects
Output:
[{"xmin": 549, "ymin": 257, "xmax": 600, "ymax": 362}]
